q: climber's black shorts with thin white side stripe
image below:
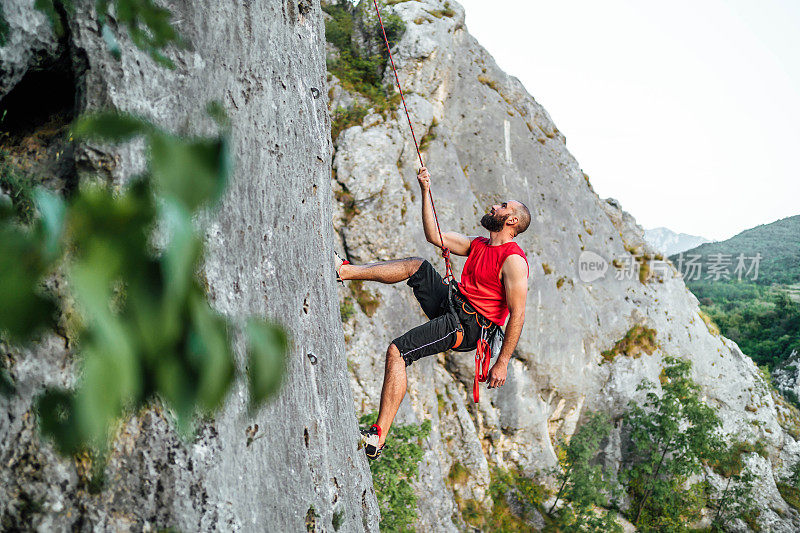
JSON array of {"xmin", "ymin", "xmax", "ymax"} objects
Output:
[{"xmin": 392, "ymin": 261, "xmax": 498, "ymax": 366}]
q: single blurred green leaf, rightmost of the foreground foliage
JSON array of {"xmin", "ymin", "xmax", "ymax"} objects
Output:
[{"xmin": 246, "ymin": 319, "xmax": 289, "ymax": 407}]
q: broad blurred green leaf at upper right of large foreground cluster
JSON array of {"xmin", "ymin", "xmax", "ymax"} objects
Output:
[{"xmin": 150, "ymin": 133, "xmax": 229, "ymax": 211}]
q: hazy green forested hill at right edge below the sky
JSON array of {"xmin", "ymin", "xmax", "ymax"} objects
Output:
[{"xmin": 670, "ymin": 215, "xmax": 800, "ymax": 288}]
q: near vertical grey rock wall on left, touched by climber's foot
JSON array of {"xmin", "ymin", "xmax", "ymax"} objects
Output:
[{"xmin": 0, "ymin": 0, "xmax": 378, "ymax": 531}]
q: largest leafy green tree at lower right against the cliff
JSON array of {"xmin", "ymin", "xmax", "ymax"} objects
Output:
[{"xmin": 620, "ymin": 357, "xmax": 751, "ymax": 531}]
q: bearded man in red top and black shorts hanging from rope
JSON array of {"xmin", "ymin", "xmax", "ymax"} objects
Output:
[{"xmin": 336, "ymin": 167, "xmax": 531, "ymax": 459}]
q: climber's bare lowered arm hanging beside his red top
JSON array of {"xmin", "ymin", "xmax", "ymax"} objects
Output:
[{"xmin": 488, "ymin": 254, "xmax": 528, "ymax": 389}]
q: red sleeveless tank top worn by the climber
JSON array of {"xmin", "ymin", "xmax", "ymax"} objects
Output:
[{"xmin": 458, "ymin": 237, "xmax": 530, "ymax": 326}]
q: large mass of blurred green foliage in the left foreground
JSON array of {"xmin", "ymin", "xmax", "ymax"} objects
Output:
[{"xmin": 0, "ymin": 105, "xmax": 288, "ymax": 454}]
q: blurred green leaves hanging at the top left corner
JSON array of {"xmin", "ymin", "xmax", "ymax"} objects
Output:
[{"xmin": 34, "ymin": 0, "xmax": 183, "ymax": 68}]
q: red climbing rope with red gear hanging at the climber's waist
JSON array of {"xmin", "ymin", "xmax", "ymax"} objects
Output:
[{"xmin": 372, "ymin": 0, "xmax": 500, "ymax": 403}]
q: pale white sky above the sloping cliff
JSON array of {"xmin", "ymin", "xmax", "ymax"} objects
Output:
[{"xmin": 460, "ymin": 0, "xmax": 800, "ymax": 240}]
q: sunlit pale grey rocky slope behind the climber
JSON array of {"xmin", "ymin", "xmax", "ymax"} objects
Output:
[{"xmin": 330, "ymin": 0, "xmax": 800, "ymax": 531}]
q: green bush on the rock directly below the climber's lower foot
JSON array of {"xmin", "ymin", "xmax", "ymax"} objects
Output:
[{"xmin": 359, "ymin": 413, "xmax": 431, "ymax": 532}]
